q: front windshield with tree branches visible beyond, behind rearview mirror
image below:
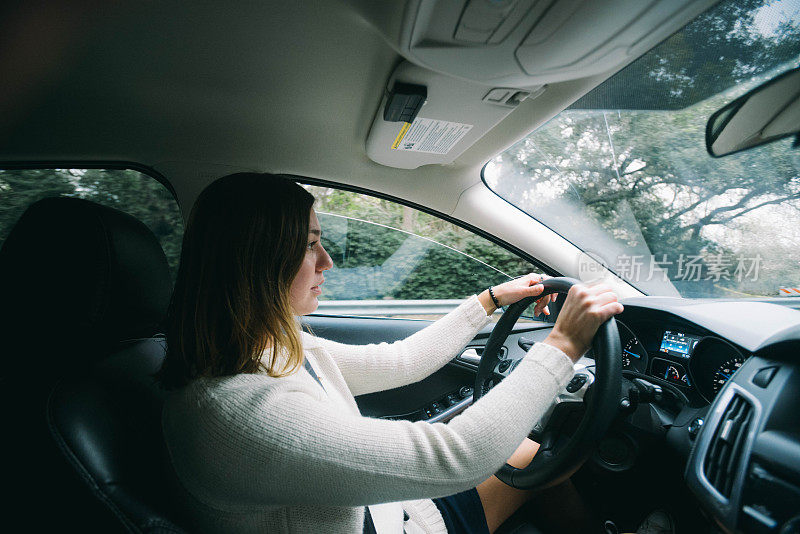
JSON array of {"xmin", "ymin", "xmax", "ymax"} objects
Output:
[{"xmin": 484, "ymin": 0, "xmax": 800, "ymax": 297}]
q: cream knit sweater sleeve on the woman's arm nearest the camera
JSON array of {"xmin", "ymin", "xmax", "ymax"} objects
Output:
[{"xmin": 163, "ymin": 343, "xmax": 572, "ymax": 512}]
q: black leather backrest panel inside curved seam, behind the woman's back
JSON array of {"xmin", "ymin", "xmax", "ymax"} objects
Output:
[{"xmin": 47, "ymin": 338, "xmax": 188, "ymax": 533}]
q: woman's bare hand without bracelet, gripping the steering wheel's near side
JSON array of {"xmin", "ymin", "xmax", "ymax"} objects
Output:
[{"xmin": 544, "ymin": 284, "xmax": 622, "ymax": 362}]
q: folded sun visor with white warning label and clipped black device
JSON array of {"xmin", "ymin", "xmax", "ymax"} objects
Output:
[{"xmin": 367, "ymin": 62, "xmax": 544, "ymax": 169}]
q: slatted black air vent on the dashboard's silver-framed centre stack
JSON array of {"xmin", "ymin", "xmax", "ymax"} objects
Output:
[{"xmin": 703, "ymin": 395, "xmax": 753, "ymax": 498}]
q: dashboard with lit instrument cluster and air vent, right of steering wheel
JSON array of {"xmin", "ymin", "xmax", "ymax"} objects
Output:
[{"xmin": 618, "ymin": 297, "xmax": 800, "ymax": 532}]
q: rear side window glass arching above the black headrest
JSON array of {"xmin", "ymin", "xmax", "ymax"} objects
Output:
[{"xmin": 0, "ymin": 169, "xmax": 183, "ymax": 277}]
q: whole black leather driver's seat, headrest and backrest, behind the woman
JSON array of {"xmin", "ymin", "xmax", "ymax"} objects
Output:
[{"xmin": 0, "ymin": 198, "xmax": 182, "ymax": 532}]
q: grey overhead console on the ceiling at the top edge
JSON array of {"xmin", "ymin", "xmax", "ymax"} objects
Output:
[{"xmin": 400, "ymin": 0, "xmax": 717, "ymax": 88}]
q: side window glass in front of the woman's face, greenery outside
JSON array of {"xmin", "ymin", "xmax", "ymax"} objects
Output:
[{"xmin": 305, "ymin": 186, "xmax": 532, "ymax": 319}]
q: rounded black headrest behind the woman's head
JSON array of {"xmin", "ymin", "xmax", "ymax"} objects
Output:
[{"xmin": 0, "ymin": 198, "xmax": 172, "ymax": 376}]
